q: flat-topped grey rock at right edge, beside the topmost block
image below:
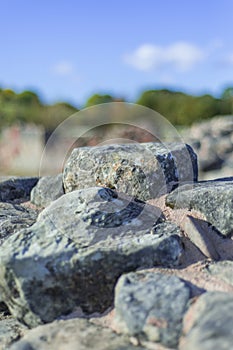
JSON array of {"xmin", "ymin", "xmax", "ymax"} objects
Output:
[{"xmin": 166, "ymin": 181, "xmax": 233, "ymax": 237}]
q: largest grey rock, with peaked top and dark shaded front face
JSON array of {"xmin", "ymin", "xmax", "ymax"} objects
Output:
[{"xmin": 0, "ymin": 187, "xmax": 183, "ymax": 327}]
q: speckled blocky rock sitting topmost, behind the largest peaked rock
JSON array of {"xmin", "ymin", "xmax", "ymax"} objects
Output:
[{"xmin": 63, "ymin": 142, "xmax": 197, "ymax": 200}]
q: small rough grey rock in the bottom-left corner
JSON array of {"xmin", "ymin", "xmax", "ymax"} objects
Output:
[{"xmin": 0, "ymin": 317, "xmax": 26, "ymax": 350}]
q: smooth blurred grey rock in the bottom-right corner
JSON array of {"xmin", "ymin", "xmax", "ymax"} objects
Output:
[{"xmin": 179, "ymin": 292, "xmax": 233, "ymax": 350}]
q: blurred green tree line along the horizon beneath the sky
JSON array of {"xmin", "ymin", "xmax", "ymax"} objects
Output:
[{"xmin": 0, "ymin": 87, "xmax": 233, "ymax": 130}]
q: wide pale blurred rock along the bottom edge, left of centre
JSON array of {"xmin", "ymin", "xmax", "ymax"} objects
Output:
[{"xmin": 10, "ymin": 319, "xmax": 145, "ymax": 350}]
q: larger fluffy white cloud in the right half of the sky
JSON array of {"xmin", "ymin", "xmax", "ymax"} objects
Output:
[{"xmin": 123, "ymin": 42, "xmax": 206, "ymax": 71}]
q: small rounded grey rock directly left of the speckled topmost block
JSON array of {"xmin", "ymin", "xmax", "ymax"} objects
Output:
[{"xmin": 31, "ymin": 174, "xmax": 64, "ymax": 207}]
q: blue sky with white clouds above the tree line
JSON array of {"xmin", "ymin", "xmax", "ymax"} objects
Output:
[{"xmin": 0, "ymin": 0, "xmax": 233, "ymax": 106}]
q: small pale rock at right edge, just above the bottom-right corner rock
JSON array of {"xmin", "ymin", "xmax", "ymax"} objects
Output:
[{"xmin": 206, "ymin": 260, "xmax": 233, "ymax": 285}]
